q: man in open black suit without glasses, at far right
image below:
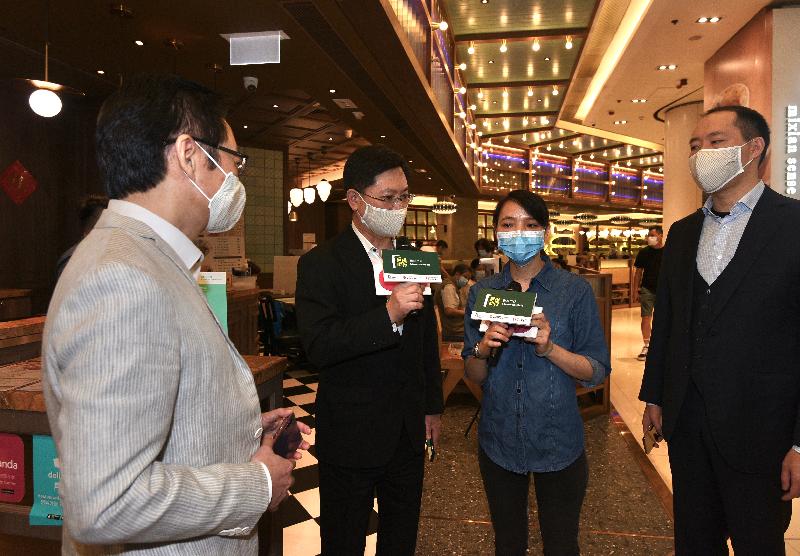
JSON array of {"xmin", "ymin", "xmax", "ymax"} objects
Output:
[{"xmin": 639, "ymin": 106, "xmax": 800, "ymax": 556}]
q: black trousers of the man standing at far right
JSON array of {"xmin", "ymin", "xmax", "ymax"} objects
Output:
[{"xmin": 669, "ymin": 383, "xmax": 792, "ymax": 556}]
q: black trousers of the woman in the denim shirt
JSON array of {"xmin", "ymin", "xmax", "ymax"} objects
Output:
[{"xmin": 478, "ymin": 447, "xmax": 589, "ymax": 556}]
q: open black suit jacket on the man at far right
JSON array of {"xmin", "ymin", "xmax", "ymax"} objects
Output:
[{"xmin": 639, "ymin": 188, "xmax": 800, "ymax": 473}]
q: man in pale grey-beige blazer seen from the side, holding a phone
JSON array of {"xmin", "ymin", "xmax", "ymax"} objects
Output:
[{"xmin": 42, "ymin": 76, "xmax": 310, "ymax": 555}]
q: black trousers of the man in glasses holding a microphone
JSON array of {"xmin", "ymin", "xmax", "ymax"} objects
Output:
[{"xmin": 319, "ymin": 429, "xmax": 425, "ymax": 556}]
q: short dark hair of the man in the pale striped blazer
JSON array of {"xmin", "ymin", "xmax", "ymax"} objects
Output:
[{"xmin": 95, "ymin": 74, "xmax": 225, "ymax": 199}]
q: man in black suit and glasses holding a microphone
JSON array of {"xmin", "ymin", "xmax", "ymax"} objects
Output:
[{"xmin": 295, "ymin": 145, "xmax": 444, "ymax": 555}]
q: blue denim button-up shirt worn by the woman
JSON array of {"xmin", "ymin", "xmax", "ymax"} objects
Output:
[{"xmin": 462, "ymin": 255, "xmax": 611, "ymax": 473}]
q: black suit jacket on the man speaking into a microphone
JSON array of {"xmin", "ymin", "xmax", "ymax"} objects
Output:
[{"xmin": 295, "ymin": 226, "xmax": 444, "ymax": 467}]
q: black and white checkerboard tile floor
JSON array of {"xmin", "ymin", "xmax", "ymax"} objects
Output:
[{"xmin": 280, "ymin": 370, "xmax": 378, "ymax": 556}]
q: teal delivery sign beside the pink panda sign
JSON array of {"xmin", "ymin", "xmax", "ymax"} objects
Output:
[{"xmin": 28, "ymin": 434, "xmax": 64, "ymax": 525}]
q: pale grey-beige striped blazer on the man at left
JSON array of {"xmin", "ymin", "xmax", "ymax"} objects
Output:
[{"xmin": 42, "ymin": 210, "xmax": 270, "ymax": 556}]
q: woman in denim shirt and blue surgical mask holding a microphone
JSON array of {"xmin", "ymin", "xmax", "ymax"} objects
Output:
[{"xmin": 463, "ymin": 190, "xmax": 611, "ymax": 556}]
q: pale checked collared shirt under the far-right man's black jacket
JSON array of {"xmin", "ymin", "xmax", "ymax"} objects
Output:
[{"xmin": 696, "ymin": 181, "xmax": 764, "ymax": 285}]
